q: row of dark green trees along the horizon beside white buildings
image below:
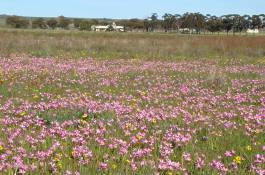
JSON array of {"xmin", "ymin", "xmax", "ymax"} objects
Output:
[{"xmin": 6, "ymin": 13, "xmax": 265, "ymax": 34}]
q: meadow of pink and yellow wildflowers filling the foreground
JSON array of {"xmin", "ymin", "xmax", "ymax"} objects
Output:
[{"xmin": 0, "ymin": 57, "xmax": 265, "ymax": 175}]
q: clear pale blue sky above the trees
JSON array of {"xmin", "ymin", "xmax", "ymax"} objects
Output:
[{"xmin": 0, "ymin": 0, "xmax": 265, "ymax": 18}]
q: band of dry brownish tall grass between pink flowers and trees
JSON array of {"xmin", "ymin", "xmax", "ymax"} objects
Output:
[{"xmin": 0, "ymin": 29, "xmax": 265, "ymax": 60}]
